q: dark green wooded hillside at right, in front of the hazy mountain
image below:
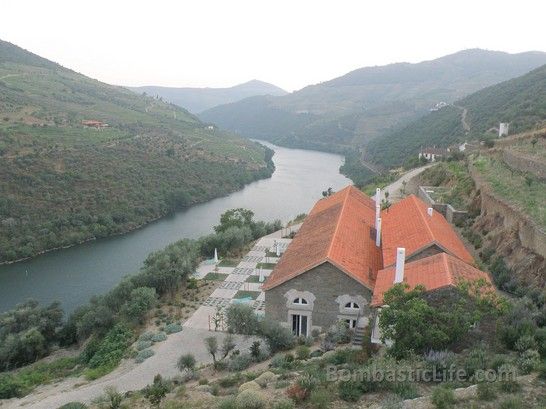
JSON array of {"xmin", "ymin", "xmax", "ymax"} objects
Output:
[{"xmin": 366, "ymin": 65, "xmax": 546, "ymax": 166}]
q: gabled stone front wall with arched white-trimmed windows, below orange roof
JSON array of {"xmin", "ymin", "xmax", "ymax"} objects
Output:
[{"xmin": 265, "ymin": 262, "xmax": 372, "ymax": 334}]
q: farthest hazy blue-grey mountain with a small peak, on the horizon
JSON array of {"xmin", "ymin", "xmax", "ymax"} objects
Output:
[{"xmin": 128, "ymin": 80, "xmax": 287, "ymax": 114}]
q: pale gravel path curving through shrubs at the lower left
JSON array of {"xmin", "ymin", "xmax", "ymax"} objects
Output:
[{"xmin": 4, "ymin": 328, "xmax": 254, "ymax": 409}]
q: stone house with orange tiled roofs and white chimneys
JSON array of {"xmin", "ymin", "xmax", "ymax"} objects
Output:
[{"xmin": 263, "ymin": 186, "xmax": 488, "ymax": 336}]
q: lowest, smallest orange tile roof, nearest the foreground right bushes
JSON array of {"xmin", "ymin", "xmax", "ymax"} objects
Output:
[{"xmin": 371, "ymin": 253, "xmax": 491, "ymax": 307}]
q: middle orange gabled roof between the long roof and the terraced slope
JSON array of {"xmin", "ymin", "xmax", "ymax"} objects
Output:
[{"xmin": 381, "ymin": 195, "xmax": 474, "ymax": 266}]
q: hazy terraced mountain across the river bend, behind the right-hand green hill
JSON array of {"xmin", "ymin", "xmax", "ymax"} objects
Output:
[{"xmin": 199, "ymin": 49, "xmax": 546, "ymax": 152}]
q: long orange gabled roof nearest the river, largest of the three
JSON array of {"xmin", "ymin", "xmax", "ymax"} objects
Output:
[{"xmin": 263, "ymin": 186, "xmax": 382, "ymax": 290}]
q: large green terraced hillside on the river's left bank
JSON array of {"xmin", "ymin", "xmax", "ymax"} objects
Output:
[{"xmin": 0, "ymin": 41, "xmax": 272, "ymax": 262}]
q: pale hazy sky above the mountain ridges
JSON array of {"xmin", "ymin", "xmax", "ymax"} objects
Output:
[{"xmin": 0, "ymin": 0, "xmax": 546, "ymax": 90}]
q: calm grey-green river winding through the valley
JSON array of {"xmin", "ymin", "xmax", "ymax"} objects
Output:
[{"xmin": 0, "ymin": 142, "xmax": 351, "ymax": 312}]
